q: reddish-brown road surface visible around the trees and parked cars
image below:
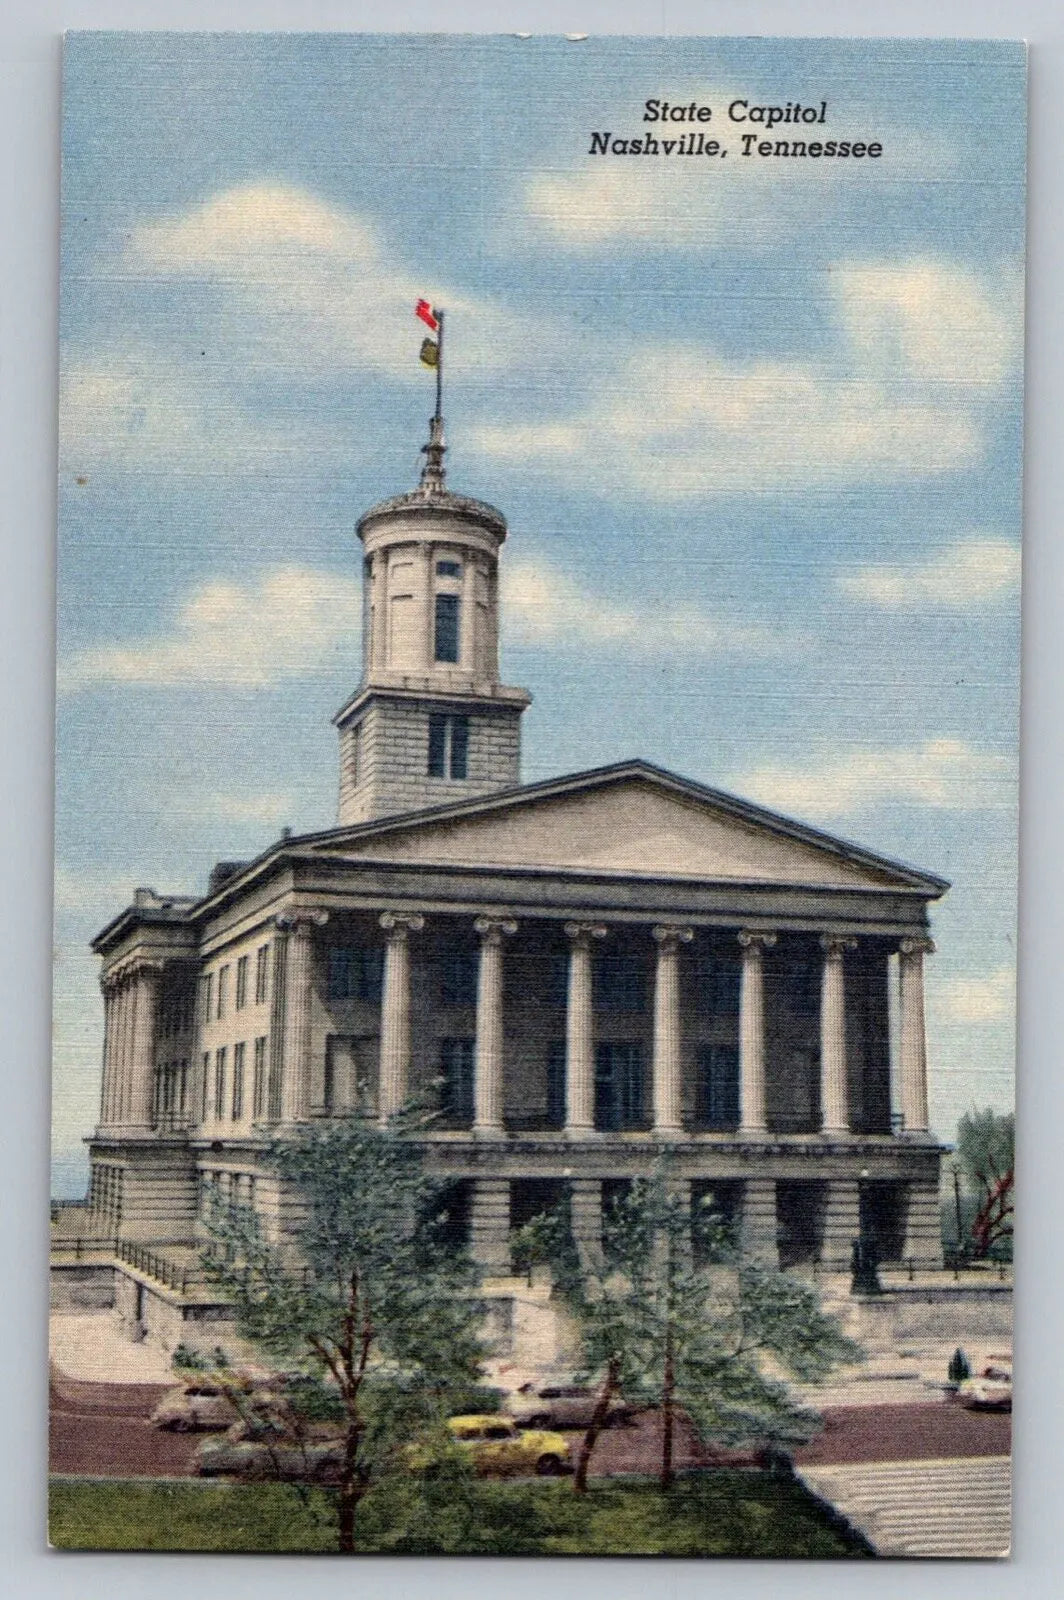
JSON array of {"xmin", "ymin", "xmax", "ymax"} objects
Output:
[{"xmin": 51, "ymin": 1379, "xmax": 1011, "ymax": 1478}]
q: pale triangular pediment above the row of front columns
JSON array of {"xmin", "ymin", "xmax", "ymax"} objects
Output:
[{"xmin": 302, "ymin": 763, "xmax": 946, "ymax": 894}]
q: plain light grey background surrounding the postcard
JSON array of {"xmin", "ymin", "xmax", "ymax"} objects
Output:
[{"xmin": 0, "ymin": 0, "xmax": 1064, "ymax": 1600}]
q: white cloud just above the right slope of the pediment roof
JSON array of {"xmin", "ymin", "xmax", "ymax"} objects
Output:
[{"xmin": 731, "ymin": 739, "xmax": 1014, "ymax": 818}]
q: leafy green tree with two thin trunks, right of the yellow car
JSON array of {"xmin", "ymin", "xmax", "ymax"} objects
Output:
[{"xmin": 531, "ymin": 1165, "xmax": 862, "ymax": 1494}]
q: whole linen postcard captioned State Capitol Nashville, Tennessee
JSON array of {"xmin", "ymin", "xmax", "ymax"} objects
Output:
[{"xmin": 50, "ymin": 32, "xmax": 1026, "ymax": 1560}]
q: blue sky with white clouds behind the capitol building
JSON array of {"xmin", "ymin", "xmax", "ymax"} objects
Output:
[{"xmin": 54, "ymin": 34, "xmax": 1024, "ymax": 1192}]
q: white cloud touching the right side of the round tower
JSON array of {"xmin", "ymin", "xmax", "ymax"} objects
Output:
[{"xmin": 502, "ymin": 562, "xmax": 794, "ymax": 654}]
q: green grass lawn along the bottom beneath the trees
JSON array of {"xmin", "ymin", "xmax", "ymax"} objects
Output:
[{"xmin": 50, "ymin": 1472, "xmax": 869, "ymax": 1557}]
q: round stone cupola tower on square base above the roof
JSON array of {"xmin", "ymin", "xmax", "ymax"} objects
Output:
[{"xmin": 334, "ymin": 380, "xmax": 531, "ymax": 826}]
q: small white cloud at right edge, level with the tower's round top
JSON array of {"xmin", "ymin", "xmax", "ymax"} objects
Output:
[{"xmin": 837, "ymin": 536, "xmax": 1019, "ymax": 611}]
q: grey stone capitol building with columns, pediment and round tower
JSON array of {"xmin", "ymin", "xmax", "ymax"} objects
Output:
[{"xmin": 90, "ymin": 412, "xmax": 947, "ymax": 1299}]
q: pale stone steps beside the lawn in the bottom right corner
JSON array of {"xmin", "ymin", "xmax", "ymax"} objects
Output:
[{"xmin": 797, "ymin": 1456, "xmax": 1011, "ymax": 1558}]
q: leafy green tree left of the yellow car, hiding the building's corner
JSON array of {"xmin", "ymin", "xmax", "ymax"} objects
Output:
[{"xmin": 203, "ymin": 1115, "xmax": 483, "ymax": 1550}]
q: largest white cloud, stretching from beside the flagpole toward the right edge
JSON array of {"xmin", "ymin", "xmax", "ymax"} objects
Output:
[{"xmin": 474, "ymin": 264, "xmax": 1018, "ymax": 499}]
